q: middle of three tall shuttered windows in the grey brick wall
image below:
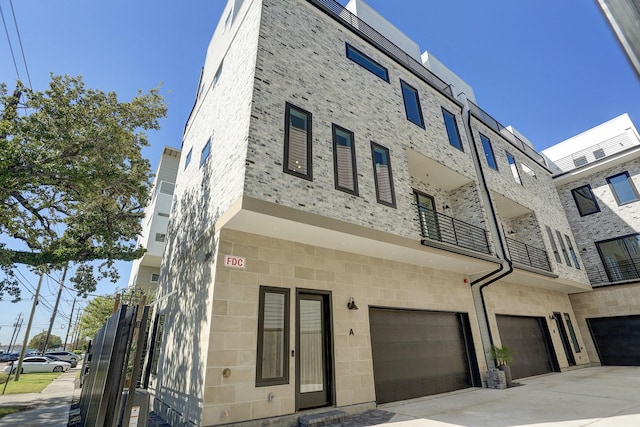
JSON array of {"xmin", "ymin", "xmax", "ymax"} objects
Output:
[{"xmin": 333, "ymin": 124, "xmax": 358, "ymax": 195}]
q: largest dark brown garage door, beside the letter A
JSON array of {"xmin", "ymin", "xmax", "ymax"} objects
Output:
[{"xmin": 369, "ymin": 308, "xmax": 478, "ymax": 403}]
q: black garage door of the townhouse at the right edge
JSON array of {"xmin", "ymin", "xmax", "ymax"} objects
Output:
[{"xmin": 587, "ymin": 315, "xmax": 640, "ymax": 366}]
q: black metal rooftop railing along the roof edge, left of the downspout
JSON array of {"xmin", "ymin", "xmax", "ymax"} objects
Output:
[{"xmin": 308, "ymin": 0, "xmax": 458, "ymax": 102}]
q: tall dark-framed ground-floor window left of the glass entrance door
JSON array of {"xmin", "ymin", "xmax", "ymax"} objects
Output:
[{"xmin": 256, "ymin": 286, "xmax": 289, "ymax": 386}]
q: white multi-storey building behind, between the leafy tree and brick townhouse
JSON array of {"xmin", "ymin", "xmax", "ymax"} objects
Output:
[{"xmin": 129, "ymin": 147, "xmax": 180, "ymax": 293}]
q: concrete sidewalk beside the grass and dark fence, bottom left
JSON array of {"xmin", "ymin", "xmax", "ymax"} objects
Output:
[{"xmin": 0, "ymin": 368, "xmax": 81, "ymax": 427}]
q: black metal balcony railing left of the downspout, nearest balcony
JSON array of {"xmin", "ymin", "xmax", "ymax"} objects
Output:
[{"xmin": 418, "ymin": 208, "xmax": 491, "ymax": 254}]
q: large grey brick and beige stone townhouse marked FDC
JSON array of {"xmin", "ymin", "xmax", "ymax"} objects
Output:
[{"xmin": 152, "ymin": 0, "xmax": 591, "ymax": 425}]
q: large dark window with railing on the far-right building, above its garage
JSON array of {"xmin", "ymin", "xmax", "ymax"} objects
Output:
[{"xmin": 596, "ymin": 234, "xmax": 640, "ymax": 282}]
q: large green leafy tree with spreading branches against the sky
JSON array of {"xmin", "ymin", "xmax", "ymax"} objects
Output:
[{"xmin": 0, "ymin": 75, "xmax": 166, "ymax": 298}]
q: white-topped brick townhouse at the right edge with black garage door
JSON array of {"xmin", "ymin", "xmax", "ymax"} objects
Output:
[{"xmin": 543, "ymin": 114, "xmax": 640, "ymax": 366}]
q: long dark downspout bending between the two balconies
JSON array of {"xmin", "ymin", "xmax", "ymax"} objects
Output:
[{"xmin": 458, "ymin": 93, "xmax": 513, "ymax": 367}]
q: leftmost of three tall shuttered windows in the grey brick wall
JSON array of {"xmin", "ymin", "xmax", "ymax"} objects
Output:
[{"xmin": 284, "ymin": 102, "xmax": 313, "ymax": 181}]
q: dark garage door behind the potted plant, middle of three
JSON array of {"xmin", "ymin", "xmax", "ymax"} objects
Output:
[{"xmin": 496, "ymin": 315, "xmax": 558, "ymax": 379}]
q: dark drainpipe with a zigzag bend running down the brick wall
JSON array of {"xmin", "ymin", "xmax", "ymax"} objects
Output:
[{"xmin": 457, "ymin": 92, "xmax": 513, "ymax": 368}]
